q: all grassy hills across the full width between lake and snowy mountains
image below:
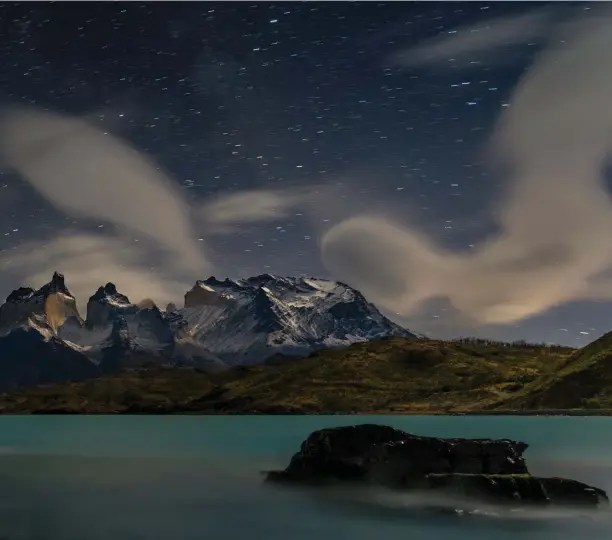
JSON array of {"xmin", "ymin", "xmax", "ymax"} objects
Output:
[{"xmin": 0, "ymin": 284, "xmax": 612, "ymax": 415}]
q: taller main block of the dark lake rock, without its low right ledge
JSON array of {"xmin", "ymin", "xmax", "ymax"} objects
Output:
[{"xmin": 274, "ymin": 424, "xmax": 527, "ymax": 487}]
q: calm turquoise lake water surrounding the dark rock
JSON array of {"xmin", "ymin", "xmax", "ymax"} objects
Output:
[{"xmin": 0, "ymin": 416, "xmax": 612, "ymax": 540}]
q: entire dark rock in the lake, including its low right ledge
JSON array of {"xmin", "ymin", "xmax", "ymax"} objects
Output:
[{"xmin": 266, "ymin": 424, "xmax": 608, "ymax": 507}]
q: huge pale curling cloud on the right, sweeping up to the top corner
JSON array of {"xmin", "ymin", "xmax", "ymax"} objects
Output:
[{"xmin": 321, "ymin": 8, "xmax": 612, "ymax": 324}]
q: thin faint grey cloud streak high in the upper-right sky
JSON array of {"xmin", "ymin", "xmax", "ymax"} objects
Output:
[{"xmin": 391, "ymin": 9, "xmax": 552, "ymax": 67}]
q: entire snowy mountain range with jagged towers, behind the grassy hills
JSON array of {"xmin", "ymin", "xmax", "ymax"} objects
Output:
[{"xmin": 0, "ymin": 272, "xmax": 423, "ymax": 391}]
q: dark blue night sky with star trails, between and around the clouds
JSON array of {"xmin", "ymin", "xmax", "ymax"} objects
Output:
[{"xmin": 0, "ymin": 2, "xmax": 612, "ymax": 346}]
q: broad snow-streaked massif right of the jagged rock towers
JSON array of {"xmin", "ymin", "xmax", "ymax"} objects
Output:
[{"xmin": 177, "ymin": 274, "xmax": 416, "ymax": 363}]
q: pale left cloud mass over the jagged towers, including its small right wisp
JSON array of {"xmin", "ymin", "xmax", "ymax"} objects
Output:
[{"xmin": 0, "ymin": 108, "xmax": 326, "ymax": 309}]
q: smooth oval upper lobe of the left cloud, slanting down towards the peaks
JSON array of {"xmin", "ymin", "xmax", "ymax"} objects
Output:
[{"xmin": 0, "ymin": 109, "xmax": 208, "ymax": 270}]
